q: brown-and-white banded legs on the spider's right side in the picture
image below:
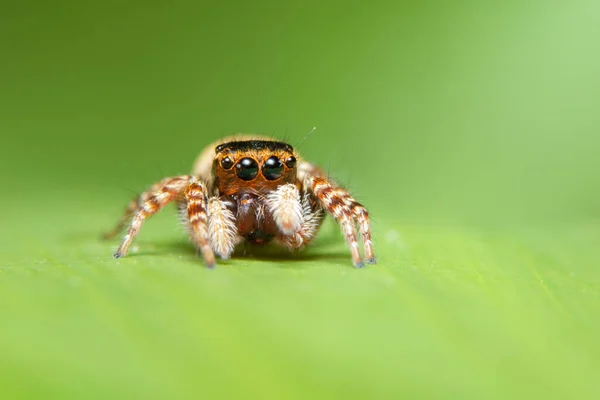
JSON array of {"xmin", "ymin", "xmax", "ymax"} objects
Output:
[{"xmin": 308, "ymin": 177, "xmax": 376, "ymax": 267}]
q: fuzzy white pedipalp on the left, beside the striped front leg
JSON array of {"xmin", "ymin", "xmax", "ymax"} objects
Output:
[{"xmin": 208, "ymin": 197, "xmax": 237, "ymax": 260}]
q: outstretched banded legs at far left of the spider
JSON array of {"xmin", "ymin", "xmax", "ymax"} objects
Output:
[{"xmin": 115, "ymin": 175, "xmax": 195, "ymax": 258}]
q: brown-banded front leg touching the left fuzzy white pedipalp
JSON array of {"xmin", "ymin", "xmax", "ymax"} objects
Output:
[{"xmin": 185, "ymin": 182, "xmax": 215, "ymax": 268}]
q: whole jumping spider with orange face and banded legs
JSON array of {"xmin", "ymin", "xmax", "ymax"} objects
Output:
[{"xmin": 106, "ymin": 137, "xmax": 375, "ymax": 267}]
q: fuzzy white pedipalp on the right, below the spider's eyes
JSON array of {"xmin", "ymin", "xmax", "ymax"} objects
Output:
[{"xmin": 267, "ymin": 183, "xmax": 303, "ymax": 235}]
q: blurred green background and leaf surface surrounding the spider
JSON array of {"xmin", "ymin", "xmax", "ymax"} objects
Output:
[{"xmin": 0, "ymin": 0, "xmax": 600, "ymax": 399}]
